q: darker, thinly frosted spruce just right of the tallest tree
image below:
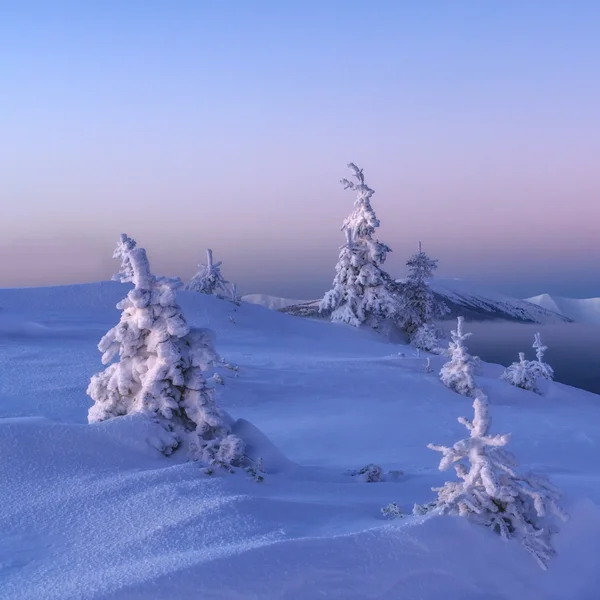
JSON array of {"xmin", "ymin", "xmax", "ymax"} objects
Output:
[{"xmin": 401, "ymin": 242, "xmax": 448, "ymax": 342}]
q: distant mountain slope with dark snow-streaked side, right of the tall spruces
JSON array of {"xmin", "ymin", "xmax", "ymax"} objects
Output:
[{"xmin": 430, "ymin": 279, "xmax": 571, "ymax": 324}]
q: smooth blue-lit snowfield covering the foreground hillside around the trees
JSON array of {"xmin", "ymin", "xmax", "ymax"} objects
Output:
[{"xmin": 0, "ymin": 283, "xmax": 600, "ymax": 600}]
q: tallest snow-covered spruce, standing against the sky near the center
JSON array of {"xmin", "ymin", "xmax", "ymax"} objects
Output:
[{"xmin": 319, "ymin": 163, "xmax": 398, "ymax": 329}]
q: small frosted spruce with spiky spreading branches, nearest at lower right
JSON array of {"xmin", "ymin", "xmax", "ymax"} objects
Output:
[{"xmin": 414, "ymin": 391, "xmax": 567, "ymax": 569}]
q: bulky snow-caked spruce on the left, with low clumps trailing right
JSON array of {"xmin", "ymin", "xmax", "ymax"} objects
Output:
[{"xmin": 87, "ymin": 241, "xmax": 245, "ymax": 471}]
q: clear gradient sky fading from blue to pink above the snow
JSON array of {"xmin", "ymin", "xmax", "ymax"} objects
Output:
[{"xmin": 0, "ymin": 0, "xmax": 600, "ymax": 298}]
